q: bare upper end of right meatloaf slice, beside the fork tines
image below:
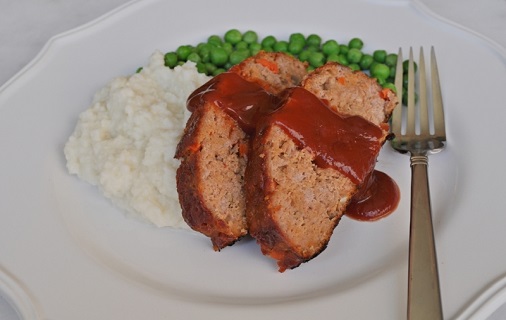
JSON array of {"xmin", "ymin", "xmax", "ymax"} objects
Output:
[{"xmin": 302, "ymin": 62, "xmax": 398, "ymax": 126}]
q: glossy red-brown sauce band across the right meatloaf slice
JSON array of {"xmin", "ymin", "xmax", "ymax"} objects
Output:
[{"xmin": 260, "ymin": 87, "xmax": 383, "ymax": 185}]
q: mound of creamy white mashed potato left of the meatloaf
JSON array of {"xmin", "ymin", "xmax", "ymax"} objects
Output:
[{"xmin": 64, "ymin": 52, "xmax": 210, "ymax": 228}]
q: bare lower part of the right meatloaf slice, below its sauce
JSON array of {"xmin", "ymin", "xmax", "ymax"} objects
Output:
[{"xmin": 246, "ymin": 125, "xmax": 357, "ymax": 272}]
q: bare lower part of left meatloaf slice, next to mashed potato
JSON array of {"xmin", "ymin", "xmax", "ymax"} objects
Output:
[{"xmin": 176, "ymin": 102, "xmax": 248, "ymax": 250}]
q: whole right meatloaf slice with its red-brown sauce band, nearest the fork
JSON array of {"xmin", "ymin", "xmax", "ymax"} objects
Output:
[{"xmin": 245, "ymin": 63, "xmax": 397, "ymax": 272}]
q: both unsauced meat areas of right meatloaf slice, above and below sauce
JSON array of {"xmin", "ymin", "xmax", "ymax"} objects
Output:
[{"xmin": 245, "ymin": 63, "xmax": 397, "ymax": 272}]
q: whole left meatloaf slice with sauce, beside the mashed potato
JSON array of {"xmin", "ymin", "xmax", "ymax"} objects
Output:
[{"xmin": 175, "ymin": 52, "xmax": 306, "ymax": 250}]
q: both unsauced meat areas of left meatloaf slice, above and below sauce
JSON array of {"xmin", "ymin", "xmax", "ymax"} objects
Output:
[{"xmin": 175, "ymin": 52, "xmax": 306, "ymax": 250}]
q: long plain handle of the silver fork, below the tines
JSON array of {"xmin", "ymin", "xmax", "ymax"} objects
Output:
[{"xmin": 408, "ymin": 153, "xmax": 443, "ymax": 320}]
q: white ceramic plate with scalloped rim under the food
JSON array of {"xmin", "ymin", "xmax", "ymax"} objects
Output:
[{"xmin": 0, "ymin": 0, "xmax": 506, "ymax": 320}]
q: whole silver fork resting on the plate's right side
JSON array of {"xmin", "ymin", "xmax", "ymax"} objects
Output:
[{"xmin": 390, "ymin": 47, "xmax": 446, "ymax": 320}]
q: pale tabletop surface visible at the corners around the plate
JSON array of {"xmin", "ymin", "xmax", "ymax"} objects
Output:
[{"xmin": 0, "ymin": 0, "xmax": 506, "ymax": 320}]
